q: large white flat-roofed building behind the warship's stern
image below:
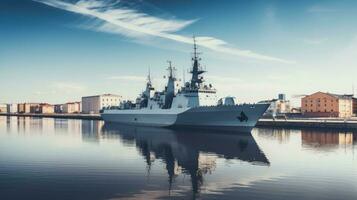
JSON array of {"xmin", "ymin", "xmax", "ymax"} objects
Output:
[{"xmin": 82, "ymin": 94, "xmax": 121, "ymax": 114}]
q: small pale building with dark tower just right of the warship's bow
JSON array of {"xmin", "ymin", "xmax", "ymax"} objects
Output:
[{"xmin": 264, "ymin": 94, "xmax": 291, "ymax": 117}]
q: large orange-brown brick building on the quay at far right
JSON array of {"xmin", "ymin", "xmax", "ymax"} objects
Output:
[{"xmin": 301, "ymin": 92, "xmax": 353, "ymax": 117}]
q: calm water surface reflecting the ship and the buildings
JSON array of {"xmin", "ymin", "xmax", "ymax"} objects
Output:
[{"xmin": 0, "ymin": 117, "xmax": 357, "ymax": 200}]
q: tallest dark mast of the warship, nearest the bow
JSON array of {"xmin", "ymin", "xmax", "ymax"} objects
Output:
[{"xmin": 190, "ymin": 37, "xmax": 205, "ymax": 89}]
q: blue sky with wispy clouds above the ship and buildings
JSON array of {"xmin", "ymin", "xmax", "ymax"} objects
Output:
[{"xmin": 0, "ymin": 0, "xmax": 357, "ymax": 103}]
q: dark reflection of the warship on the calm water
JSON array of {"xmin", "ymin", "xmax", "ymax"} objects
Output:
[{"xmin": 103, "ymin": 124, "xmax": 270, "ymax": 197}]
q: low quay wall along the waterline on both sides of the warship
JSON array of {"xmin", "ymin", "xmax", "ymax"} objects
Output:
[{"xmin": 0, "ymin": 113, "xmax": 357, "ymax": 130}]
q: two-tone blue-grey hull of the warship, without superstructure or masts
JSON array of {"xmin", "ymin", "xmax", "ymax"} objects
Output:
[{"xmin": 101, "ymin": 104, "xmax": 269, "ymax": 132}]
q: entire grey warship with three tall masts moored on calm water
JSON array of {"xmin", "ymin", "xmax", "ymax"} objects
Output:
[{"xmin": 101, "ymin": 38, "xmax": 270, "ymax": 132}]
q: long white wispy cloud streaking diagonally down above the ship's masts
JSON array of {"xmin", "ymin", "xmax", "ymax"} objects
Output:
[{"xmin": 34, "ymin": 0, "xmax": 294, "ymax": 64}]
